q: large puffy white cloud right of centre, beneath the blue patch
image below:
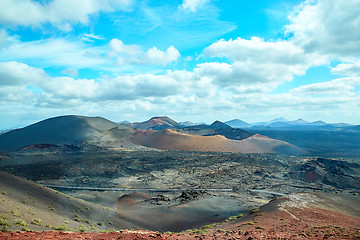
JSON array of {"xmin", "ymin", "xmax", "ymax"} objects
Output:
[{"xmin": 201, "ymin": 37, "xmax": 325, "ymax": 91}]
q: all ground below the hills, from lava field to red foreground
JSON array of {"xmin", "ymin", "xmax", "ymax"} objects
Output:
[{"xmin": 0, "ymin": 149, "xmax": 360, "ymax": 239}]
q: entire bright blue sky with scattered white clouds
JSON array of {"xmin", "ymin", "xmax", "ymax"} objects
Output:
[{"xmin": 0, "ymin": 0, "xmax": 360, "ymax": 129}]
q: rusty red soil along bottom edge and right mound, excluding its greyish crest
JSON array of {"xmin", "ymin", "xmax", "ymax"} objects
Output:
[{"xmin": 0, "ymin": 205, "xmax": 360, "ymax": 240}]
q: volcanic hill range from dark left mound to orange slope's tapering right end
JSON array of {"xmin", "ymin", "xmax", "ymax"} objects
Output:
[{"xmin": 0, "ymin": 116, "xmax": 305, "ymax": 154}]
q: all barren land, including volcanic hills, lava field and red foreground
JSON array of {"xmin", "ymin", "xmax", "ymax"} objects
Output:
[{"xmin": 0, "ymin": 116, "xmax": 360, "ymax": 239}]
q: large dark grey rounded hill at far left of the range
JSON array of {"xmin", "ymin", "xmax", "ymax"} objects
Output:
[{"xmin": 0, "ymin": 115, "xmax": 129, "ymax": 150}]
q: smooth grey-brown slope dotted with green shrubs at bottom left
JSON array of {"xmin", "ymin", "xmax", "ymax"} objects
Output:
[{"xmin": 0, "ymin": 172, "xmax": 146, "ymax": 231}]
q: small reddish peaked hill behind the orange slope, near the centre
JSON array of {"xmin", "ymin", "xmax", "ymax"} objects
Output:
[{"xmin": 133, "ymin": 116, "xmax": 183, "ymax": 130}]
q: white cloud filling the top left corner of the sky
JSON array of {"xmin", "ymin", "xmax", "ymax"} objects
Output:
[{"xmin": 0, "ymin": 0, "xmax": 133, "ymax": 31}]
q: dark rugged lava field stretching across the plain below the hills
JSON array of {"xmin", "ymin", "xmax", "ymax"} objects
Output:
[{"xmin": 0, "ymin": 149, "xmax": 360, "ymax": 222}]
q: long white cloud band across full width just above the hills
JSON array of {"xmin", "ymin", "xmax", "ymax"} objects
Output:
[{"xmin": 0, "ymin": 59, "xmax": 360, "ymax": 126}]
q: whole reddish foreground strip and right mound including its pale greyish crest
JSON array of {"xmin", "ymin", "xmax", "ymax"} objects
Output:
[{"xmin": 0, "ymin": 193, "xmax": 360, "ymax": 240}]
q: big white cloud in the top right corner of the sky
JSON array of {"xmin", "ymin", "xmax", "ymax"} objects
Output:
[{"xmin": 286, "ymin": 0, "xmax": 360, "ymax": 57}]
